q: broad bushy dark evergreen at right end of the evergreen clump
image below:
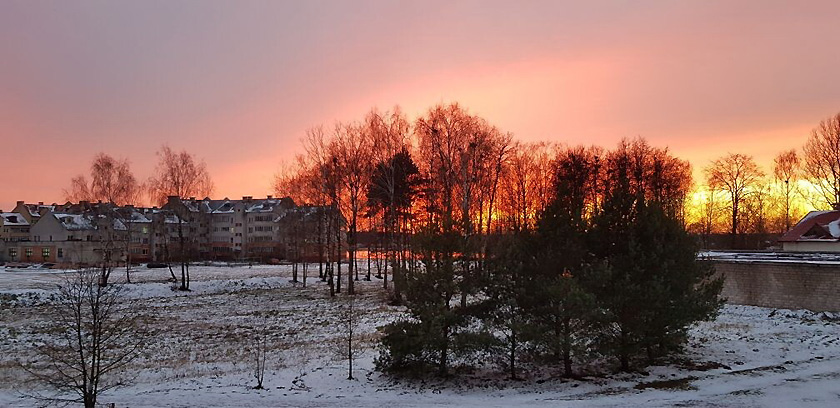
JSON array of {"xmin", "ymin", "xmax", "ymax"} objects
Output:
[{"xmin": 588, "ymin": 186, "xmax": 722, "ymax": 371}]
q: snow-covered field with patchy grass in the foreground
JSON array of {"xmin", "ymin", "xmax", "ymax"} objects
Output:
[{"xmin": 0, "ymin": 266, "xmax": 840, "ymax": 407}]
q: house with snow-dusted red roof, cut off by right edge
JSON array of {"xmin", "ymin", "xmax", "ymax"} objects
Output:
[{"xmin": 779, "ymin": 210, "xmax": 840, "ymax": 252}]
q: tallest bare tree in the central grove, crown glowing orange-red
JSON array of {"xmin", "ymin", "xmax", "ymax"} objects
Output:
[{"xmin": 415, "ymin": 104, "xmax": 511, "ymax": 306}]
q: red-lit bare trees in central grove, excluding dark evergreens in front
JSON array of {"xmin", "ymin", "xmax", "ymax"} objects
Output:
[{"xmin": 275, "ymin": 104, "xmax": 691, "ymax": 302}]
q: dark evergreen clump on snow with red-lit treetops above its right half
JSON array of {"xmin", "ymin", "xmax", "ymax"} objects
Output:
[{"xmin": 379, "ymin": 140, "xmax": 722, "ymax": 378}]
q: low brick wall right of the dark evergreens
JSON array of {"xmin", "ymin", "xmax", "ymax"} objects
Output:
[{"xmin": 714, "ymin": 261, "xmax": 840, "ymax": 312}]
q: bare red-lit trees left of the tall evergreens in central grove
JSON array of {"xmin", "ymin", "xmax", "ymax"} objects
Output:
[{"xmin": 275, "ymin": 104, "xmax": 553, "ymax": 300}]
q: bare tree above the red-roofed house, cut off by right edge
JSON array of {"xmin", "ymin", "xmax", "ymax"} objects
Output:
[{"xmin": 802, "ymin": 113, "xmax": 840, "ymax": 209}]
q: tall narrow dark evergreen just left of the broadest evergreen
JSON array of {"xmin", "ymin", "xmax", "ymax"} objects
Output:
[{"xmin": 526, "ymin": 145, "xmax": 599, "ymax": 377}]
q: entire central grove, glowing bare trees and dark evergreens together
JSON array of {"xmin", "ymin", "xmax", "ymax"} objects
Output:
[{"xmin": 276, "ymin": 104, "xmax": 721, "ymax": 377}]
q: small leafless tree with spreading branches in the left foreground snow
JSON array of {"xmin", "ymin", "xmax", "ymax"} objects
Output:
[{"xmin": 23, "ymin": 269, "xmax": 144, "ymax": 408}]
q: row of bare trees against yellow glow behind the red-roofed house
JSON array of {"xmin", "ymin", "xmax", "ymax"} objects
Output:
[{"xmin": 688, "ymin": 114, "xmax": 840, "ymax": 242}]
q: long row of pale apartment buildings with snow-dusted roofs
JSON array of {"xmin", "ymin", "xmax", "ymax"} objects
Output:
[{"xmin": 0, "ymin": 196, "xmax": 343, "ymax": 264}]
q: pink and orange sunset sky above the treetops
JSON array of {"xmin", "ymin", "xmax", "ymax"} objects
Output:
[{"xmin": 0, "ymin": 0, "xmax": 840, "ymax": 210}]
